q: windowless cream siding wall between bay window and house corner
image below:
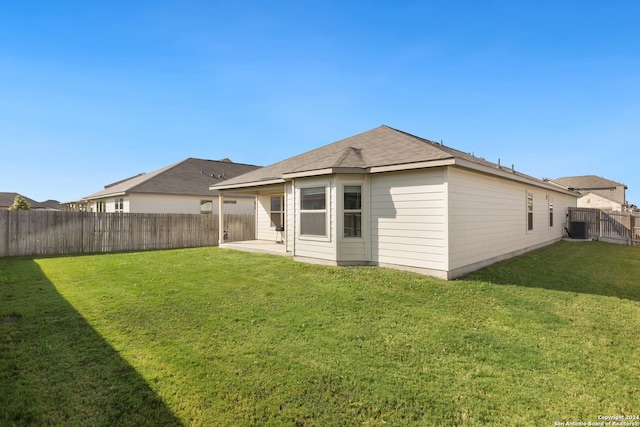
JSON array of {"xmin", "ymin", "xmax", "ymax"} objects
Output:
[{"xmin": 370, "ymin": 168, "xmax": 447, "ymax": 270}]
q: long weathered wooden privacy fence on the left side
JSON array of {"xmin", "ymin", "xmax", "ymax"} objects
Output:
[{"xmin": 0, "ymin": 210, "xmax": 255, "ymax": 257}]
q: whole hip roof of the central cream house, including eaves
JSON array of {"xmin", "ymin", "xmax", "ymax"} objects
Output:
[{"xmin": 212, "ymin": 125, "xmax": 576, "ymax": 196}]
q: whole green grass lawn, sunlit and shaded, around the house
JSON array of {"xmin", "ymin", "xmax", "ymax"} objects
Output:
[{"xmin": 0, "ymin": 242, "xmax": 640, "ymax": 426}]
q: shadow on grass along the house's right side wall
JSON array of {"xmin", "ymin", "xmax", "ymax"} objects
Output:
[{"xmin": 460, "ymin": 242, "xmax": 640, "ymax": 301}]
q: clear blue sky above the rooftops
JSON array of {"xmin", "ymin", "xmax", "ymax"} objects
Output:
[{"xmin": 0, "ymin": 0, "xmax": 640, "ymax": 204}]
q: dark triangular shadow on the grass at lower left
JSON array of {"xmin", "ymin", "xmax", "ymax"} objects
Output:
[{"xmin": 0, "ymin": 258, "xmax": 182, "ymax": 426}]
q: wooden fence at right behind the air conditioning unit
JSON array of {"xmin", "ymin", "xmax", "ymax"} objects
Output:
[{"xmin": 569, "ymin": 208, "xmax": 640, "ymax": 246}]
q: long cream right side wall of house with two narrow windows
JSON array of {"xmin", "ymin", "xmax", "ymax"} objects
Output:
[{"xmin": 447, "ymin": 167, "xmax": 576, "ymax": 277}]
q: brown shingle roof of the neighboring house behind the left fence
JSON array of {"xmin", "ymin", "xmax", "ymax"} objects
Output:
[{"xmin": 84, "ymin": 158, "xmax": 259, "ymax": 200}]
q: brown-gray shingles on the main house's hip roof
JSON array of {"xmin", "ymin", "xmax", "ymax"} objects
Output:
[{"xmin": 214, "ymin": 125, "xmax": 541, "ymax": 188}]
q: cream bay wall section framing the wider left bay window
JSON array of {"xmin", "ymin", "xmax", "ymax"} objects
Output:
[{"xmin": 294, "ymin": 176, "xmax": 337, "ymax": 262}]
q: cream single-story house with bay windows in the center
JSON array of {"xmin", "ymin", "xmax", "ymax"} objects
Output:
[{"xmin": 211, "ymin": 126, "xmax": 577, "ymax": 279}]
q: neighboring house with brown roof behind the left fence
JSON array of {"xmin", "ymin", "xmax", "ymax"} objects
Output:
[{"xmin": 83, "ymin": 158, "xmax": 259, "ymax": 214}]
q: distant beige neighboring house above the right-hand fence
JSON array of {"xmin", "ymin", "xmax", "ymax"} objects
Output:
[{"xmin": 545, "ymin": 175, "xmax": 628, "ymax": 212}]
